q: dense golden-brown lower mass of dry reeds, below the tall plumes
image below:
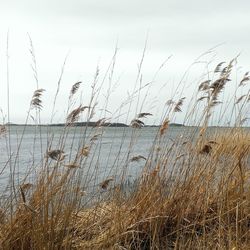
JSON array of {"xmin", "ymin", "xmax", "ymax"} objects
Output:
[{"xmin": 0, "ymin": 130, "xmax": 250, "ymax": 249}]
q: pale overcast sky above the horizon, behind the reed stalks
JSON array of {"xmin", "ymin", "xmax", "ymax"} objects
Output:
[{"xmin": 0, "ymin": 0, "xmax": 250, "ymax": 123}]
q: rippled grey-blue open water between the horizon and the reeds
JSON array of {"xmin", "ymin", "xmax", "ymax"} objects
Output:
[{"xmin": 0, "ymin": 126, "xmax": 247, "ymax": 190}]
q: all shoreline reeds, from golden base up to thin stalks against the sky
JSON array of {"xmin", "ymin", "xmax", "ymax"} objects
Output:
[{"xmin": 0, "ymin": 51, "xmax": 250, "ymax": 250}]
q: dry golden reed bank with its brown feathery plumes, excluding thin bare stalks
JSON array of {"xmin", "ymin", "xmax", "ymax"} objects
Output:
[{"xmin": 0, "ymin": 56, "xmax": 250, "ymax": 249}]
